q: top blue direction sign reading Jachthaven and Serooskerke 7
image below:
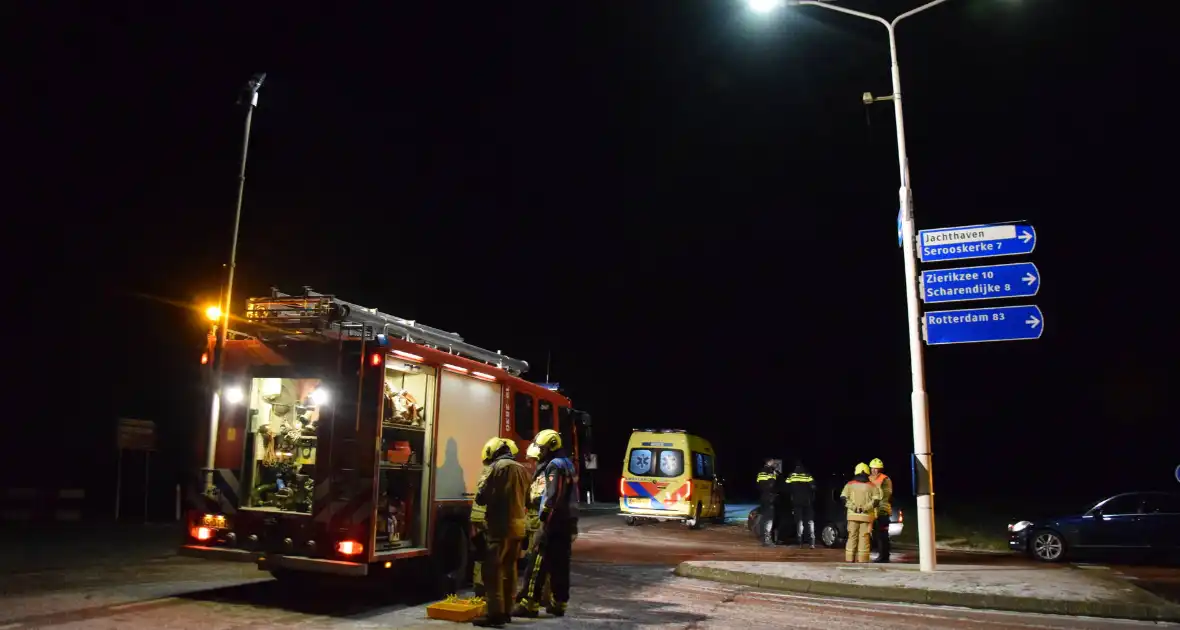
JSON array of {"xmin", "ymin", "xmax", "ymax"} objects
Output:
[{"xmin": 918, "ymin": 223, "xmax": 1036, "ymax": 262}]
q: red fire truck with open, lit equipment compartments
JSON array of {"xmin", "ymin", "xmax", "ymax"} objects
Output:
[{"xmin": 181, "ymin": 289, "xmax": 590, "ymax": 588}]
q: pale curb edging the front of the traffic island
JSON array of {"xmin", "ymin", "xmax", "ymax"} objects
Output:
[{"xmin": 675, "ymin": 563, "xmax": 1180, "ymax": 622}]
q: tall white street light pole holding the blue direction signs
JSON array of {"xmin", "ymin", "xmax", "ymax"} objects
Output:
[{"xmin": 792, "ymin": 0, "xmax": 946, "ymax": 571}]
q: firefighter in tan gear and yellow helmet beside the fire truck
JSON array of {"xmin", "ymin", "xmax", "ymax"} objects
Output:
[{"xmin": 471, "ymin": 438, "xmax": 529, "ymax": 628}]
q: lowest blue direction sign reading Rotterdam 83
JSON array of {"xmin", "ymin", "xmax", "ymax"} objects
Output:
[{"xmin": 923, "ymin": 306, "xmax": 1044, "ymax": 346}]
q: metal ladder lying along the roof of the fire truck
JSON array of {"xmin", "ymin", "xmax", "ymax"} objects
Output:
[{"xmin": 245, "ymin": 287, "xmax": 529, "ymax": 376}]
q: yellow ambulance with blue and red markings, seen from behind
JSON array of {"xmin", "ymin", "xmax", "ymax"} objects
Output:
[{"xmin": 618, "ymin": 428, "xmax": 726, "ymax": 529}]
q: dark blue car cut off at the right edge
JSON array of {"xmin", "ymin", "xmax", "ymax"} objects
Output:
[{"xmin": 1008, "ymin": 492, "xmax": 1180, "ymax": 562}]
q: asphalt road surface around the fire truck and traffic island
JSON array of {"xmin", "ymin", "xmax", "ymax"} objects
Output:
[{"xmin": 0, "ymin": 516, "xmax": 1175, "ymax": 630}]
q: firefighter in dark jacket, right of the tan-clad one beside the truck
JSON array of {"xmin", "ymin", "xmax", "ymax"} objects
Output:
[{"xmin": 512, "ymin": 428, "xmax": 578, "ymax": 617}]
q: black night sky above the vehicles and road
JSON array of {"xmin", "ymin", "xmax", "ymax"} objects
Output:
[{"xmin": 11, "ymin": 0, "xmax": 1180, "ymax": 514}]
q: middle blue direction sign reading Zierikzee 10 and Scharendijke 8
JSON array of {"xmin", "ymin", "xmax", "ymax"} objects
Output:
[{"xmin": 922, "ymin": 263, "xmax": 1041, "ymax": 304}]
